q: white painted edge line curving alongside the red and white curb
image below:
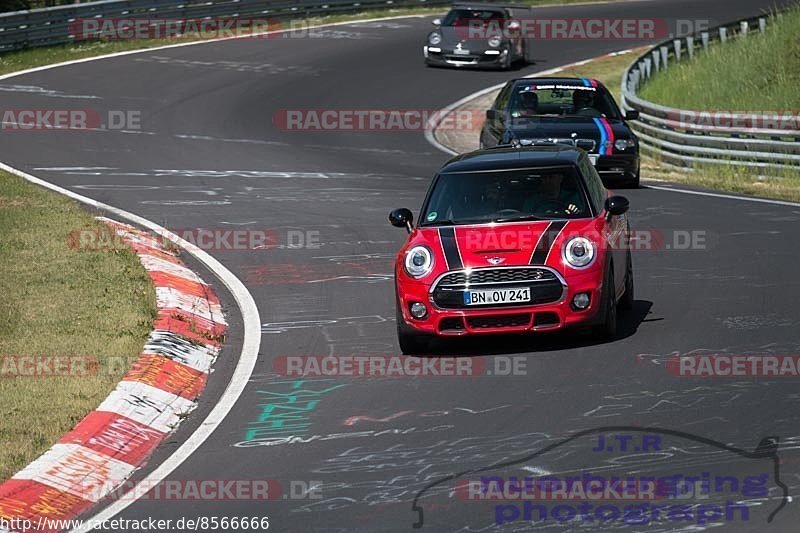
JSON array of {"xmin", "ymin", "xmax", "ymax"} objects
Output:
[{"xmin": 0, "ymin": 163, "xmax": 261, "ymax": 531}]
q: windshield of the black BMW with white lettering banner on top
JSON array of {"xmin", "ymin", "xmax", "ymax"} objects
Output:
[{"xmin": 508, "ymin": 84, "xmax": 619, "ymax": 119}]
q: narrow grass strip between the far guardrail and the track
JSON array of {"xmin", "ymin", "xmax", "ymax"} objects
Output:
[{"xmin": 0, "ymin": 0, "xmax": 624, "ymax": 74}]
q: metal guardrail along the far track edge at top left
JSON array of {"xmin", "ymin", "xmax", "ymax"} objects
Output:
[{"xmin": 0, "ymin": 0, "xmax": 451, "ymax": 53}]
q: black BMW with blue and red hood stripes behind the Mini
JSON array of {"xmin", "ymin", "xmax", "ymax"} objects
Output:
[{"xmin": 480, "ymin": 78, "xmax": 639, "ymax": 187}]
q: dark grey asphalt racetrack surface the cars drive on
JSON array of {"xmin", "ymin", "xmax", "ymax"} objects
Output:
[{"xmin": 0, "ymin": 0, "xmax": 800, "ymax": 532}]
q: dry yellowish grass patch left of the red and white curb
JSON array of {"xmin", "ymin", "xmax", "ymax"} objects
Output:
[{"xmin": 0, "ymin": 172, "xmax": 156, "ymax": 480}]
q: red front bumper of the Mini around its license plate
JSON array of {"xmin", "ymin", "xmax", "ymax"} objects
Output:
[{"xmin": 397, "ymin": 271, "xmax": 603, "ymax": 337}]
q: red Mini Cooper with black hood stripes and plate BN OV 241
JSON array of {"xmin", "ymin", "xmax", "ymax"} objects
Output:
[{"xmin": 389, "ymin": 145, "xmax": 634, "ymax": 354}]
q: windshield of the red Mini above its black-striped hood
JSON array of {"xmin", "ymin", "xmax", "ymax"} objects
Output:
[{"xmin": 420, "ymin": 166, "xmax": 590, "ymax": 226}]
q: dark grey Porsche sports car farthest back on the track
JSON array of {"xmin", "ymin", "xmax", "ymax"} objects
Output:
[{"xmin": 423, "ymin": 4, "xmax": 530, "ymax": 69}]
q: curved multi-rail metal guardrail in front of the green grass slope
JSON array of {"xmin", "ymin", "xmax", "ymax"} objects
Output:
[{"xmin": 621, "ymin": 12, "xmax": 800, "ymax": 167}]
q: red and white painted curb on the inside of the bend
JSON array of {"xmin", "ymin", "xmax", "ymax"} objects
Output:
[{"xmin": 0, "ymin": 217, "xmax": 227, "ymax": 531}]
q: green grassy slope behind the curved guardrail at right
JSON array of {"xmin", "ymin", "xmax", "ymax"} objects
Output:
[{"xmin": 639, "ymin": 6, "xmax": 800, "ymax": 113}]
